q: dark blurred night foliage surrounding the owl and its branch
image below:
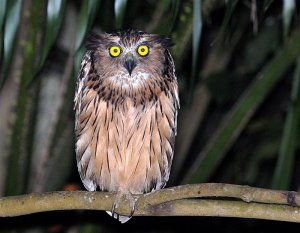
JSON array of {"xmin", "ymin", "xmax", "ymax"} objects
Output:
[{"xmin": 0, "ymin": 0, "xmax": 300, "ymax": 233}]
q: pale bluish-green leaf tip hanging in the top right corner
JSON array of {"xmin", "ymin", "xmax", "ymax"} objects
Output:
[{"xmin": 282, "ymin": 0, "xmax": 296, "ymax": 39}]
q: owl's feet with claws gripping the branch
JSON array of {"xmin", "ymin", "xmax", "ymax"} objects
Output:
[{"xmin": 111, "ymin": 192, "xmax": 136, "ymax": 223}]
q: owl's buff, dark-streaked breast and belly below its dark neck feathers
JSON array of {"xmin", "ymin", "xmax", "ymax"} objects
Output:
[{"xmin": 76, "ymin": 86, "xmax": 176, "ymax": 192}]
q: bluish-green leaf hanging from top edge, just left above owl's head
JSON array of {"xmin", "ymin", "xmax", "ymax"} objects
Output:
[{"xmin": 75, "ymin": 0, "xmax": 100, "ymax": 51}]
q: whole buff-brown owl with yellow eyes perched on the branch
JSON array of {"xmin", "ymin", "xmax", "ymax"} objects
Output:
[{"xmin": 74, "ymin": 29, "xmax": 179, "ymax": 222}]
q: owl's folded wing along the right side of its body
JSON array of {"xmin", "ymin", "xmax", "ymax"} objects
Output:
[{"xmin": 146, "ymin": 50, "xmax": 179, "ymax": 192}]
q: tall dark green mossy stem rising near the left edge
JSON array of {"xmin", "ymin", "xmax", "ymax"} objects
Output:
[{"xmin": 5, "ymin": 0, "xmax": 47, "ymax": 195}]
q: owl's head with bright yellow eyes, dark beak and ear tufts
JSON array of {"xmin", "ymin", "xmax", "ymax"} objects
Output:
[{"xmin": 86, "ymin": 29, "xmax": 173, "ymax": 79}]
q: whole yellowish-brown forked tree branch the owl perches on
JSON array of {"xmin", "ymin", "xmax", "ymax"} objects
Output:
[{"xmin": 0, "ymin": 183, "xmax": 300, "ymax": 222}]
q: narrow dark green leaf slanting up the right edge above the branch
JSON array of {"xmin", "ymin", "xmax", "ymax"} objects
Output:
[{"xmin": 272, "ymin": 57, "xmax": 300, "ymax": 189}]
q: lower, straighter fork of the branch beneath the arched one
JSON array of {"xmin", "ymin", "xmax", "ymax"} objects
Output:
[{"xmin": 140, "ymin": 200, "xmax": 300, "ymax": 222}]
